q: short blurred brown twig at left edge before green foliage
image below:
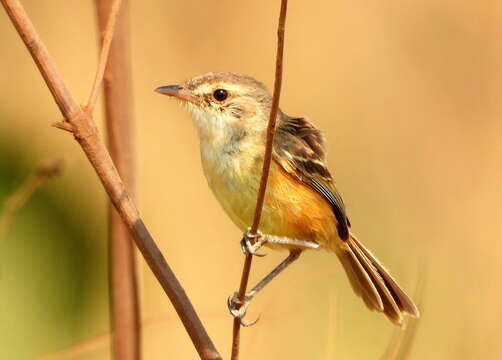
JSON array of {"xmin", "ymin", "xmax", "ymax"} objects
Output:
[{"xmin": 0, "ymin": 159, "xmax": 64, "ymax": 241}]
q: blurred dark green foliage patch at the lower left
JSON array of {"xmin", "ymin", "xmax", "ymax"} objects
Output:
[{"xmin": 0, "ymin": 148, "xmax": 106, "ymax": 360}]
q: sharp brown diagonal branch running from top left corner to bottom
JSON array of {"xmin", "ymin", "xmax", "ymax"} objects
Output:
[{"xmin": 0, "ymin": 0, "xmax": 221, "ymax": 359}]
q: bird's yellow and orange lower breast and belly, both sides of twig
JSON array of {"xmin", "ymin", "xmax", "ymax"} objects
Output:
[{"xmin": 201, "ymin": 136, "xmax": 336, "ymax": 246}]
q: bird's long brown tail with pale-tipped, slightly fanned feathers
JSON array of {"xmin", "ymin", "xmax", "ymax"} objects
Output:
[{"xmin": 337, "ymin": 234, "xmax": 420, "ymax": 325}]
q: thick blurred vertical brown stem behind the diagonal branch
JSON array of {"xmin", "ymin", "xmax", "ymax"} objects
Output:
[{"xmin": 94, "ymin": 0, "xmax": 141, "ymax": 360}]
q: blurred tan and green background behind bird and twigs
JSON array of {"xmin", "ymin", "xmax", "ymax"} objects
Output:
[{"xmin": 0, "ymin": 0, "xmax": 502, "ymax": 360}]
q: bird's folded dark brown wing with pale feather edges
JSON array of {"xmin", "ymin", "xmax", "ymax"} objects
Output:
[{"xmin": 273, "ymin": 114, "xmax": 350, "ymax": 240}]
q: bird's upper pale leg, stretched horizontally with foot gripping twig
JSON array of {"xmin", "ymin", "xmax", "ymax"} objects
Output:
[{"xmin": 241, "ymin": 228, "xmax": 320, "ymax": 257}]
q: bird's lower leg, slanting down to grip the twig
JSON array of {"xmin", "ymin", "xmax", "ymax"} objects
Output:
[{"xmin": 227, "ymin": 249, "xmax": 302, "ymax": 326}]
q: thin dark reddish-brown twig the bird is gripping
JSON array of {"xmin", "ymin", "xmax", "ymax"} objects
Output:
[{"xmin": 231, "ymin": 0, "xmax": 288, "ymax": 360}]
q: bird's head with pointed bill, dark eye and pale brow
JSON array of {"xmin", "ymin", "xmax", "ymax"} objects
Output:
[{"xmin": 155, "ymin": 72, "xmax": 272, "ymax": 140}]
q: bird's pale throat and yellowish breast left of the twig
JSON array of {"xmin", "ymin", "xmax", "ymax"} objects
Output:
[{"xmin": 184, "ymin": 101, "xmax": 264, "ymax": 229}]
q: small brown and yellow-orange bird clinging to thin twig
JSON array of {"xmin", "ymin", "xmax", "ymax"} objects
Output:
[{"xmin": 156, "ymin": 72, "xmax": 419, "ymax": 325}]
